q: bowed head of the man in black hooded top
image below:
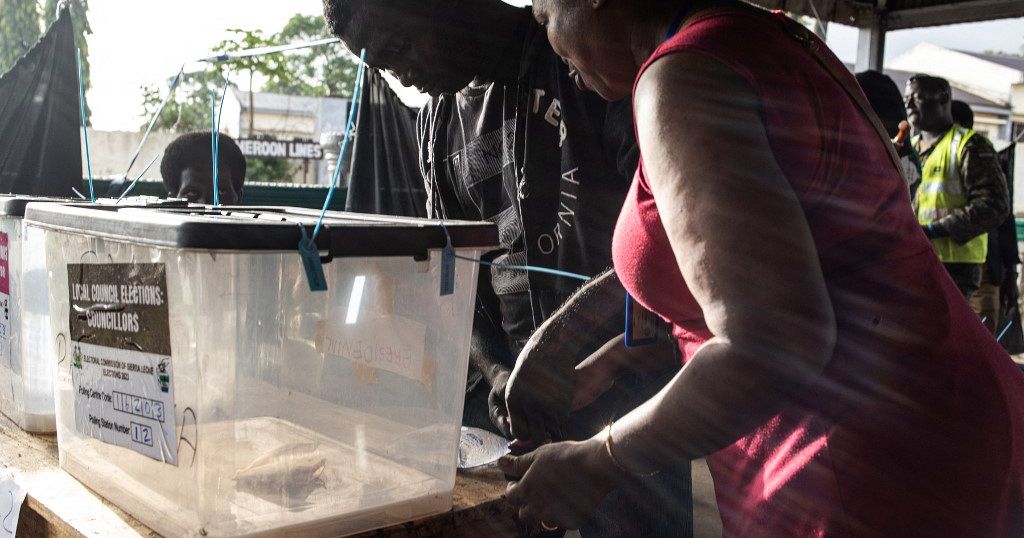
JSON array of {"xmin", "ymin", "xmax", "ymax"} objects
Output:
[{"xmin": 324, "ymin": 0, "xmax": 504, "ymax": 95}]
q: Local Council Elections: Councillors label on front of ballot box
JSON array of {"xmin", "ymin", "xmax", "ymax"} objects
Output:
[{"xmin": 68, "ymin": 263, "xmax": 177, "ymax": 465}]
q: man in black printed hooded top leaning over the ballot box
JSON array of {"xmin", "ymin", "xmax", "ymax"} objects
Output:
[{"xmin": 324, "ymin": 0, "xmax": 692, "ymax": 537}]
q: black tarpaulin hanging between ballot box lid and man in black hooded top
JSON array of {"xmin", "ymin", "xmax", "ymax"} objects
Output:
[{"xmin": 345, "ymin": 69, "xmax": 427, "ymax": 217}]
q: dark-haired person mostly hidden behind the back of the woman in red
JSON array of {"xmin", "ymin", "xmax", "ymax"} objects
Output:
[{"xmin": 856, "ymin": 70, "xmax": 921, "ymax": 200}]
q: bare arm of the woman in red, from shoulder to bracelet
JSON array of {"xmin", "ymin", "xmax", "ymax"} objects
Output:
[{"xmin": 612, "ymin": 53, "xmax": 836, "ymax": 471}]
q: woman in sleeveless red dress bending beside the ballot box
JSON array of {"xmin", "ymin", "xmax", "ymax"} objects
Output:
[{"xmin": 503, "ymin": 0, "xmax": 1024, "ymax": 537}]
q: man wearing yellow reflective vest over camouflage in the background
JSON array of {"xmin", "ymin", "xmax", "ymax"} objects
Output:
[{"xmin": 904, "ymin": 75, "xmax": 1010, "ymax": 299}]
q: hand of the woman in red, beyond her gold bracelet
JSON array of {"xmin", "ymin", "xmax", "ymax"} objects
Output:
[{"xmin": 499, "ymin": 434, "xmax": 628, "ymax": 529}]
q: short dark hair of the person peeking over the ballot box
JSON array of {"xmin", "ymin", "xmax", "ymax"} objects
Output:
[{"xmin": 160, "ymin": 131, "xmax": 246, "ymax": 193}]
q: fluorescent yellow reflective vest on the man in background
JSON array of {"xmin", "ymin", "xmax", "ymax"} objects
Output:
[{"xmin": 913, "ymin": 125, "xmax": 988, "ymax": 263}]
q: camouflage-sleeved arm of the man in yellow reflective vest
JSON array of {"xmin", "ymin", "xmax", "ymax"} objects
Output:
[{"xmin": 931, "ymin": 134, "xmax": 1010, "ymax": 244}]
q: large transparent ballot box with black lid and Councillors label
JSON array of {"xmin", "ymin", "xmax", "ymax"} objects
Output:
[{"xmin": 26, "ymin": 204, "xmax": 497, "ymax": 537}]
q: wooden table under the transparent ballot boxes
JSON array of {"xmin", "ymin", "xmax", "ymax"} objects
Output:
[{"xmin": 0, "ymin": 415, "xmax": 516, "ymax": 538}]
